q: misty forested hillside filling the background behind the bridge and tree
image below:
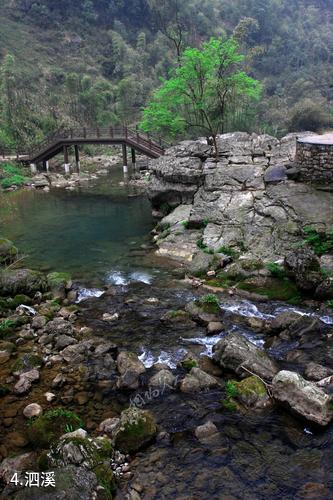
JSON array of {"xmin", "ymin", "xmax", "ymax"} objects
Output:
[{"xmin": 0, "ymin": 0, "xmax": 333, "ymax": 147}]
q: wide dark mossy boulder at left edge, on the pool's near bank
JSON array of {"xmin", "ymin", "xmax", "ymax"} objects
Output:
[{"xmin": 0, "ymin": 269, "xmax": 47, "ymax": 297}]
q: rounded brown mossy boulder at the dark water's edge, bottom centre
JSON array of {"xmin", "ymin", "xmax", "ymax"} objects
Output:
[{"xmin": 114, "ymin": 406, "xmax": 157, "ymax": 453}]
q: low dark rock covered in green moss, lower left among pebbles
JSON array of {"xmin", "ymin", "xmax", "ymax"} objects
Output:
[{"xmin": 27, "ymin": 408, "xmax": 83, "ymax": 449}]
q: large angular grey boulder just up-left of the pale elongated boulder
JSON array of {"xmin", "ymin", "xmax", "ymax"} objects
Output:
[{"xmin": 213, "ymin": 332, "xmax": 278, "ymax": 380}]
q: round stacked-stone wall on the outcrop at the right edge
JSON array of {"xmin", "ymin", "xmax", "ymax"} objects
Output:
[{"xmin": 296, "ymin": 141, "xmax": 333, "ymax": 184}]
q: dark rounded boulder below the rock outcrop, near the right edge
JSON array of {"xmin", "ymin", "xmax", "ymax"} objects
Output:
[{"xmin": 284, "ymin": 248, "xmax": 323, "ymax": 291}]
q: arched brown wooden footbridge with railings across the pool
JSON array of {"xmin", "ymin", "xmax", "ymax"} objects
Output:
[{"xmin": 1, "ymin": 126, "xmax": 169, "ymax": 171}]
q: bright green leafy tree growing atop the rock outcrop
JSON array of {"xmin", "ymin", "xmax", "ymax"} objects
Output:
[{"xmin": 141, "ymin": 38, "xmax": 261, "ymax": 154}]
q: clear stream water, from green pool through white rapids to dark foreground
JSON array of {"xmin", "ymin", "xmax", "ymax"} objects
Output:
[{"xmin": 0, "ymin": 169, "xmax": 333, "ymax": 500}]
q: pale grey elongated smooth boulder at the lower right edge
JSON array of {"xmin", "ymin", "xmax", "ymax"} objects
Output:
[{"xmin": 272, "ymin": 370, "xmax": 333, "ymax": 426}]
